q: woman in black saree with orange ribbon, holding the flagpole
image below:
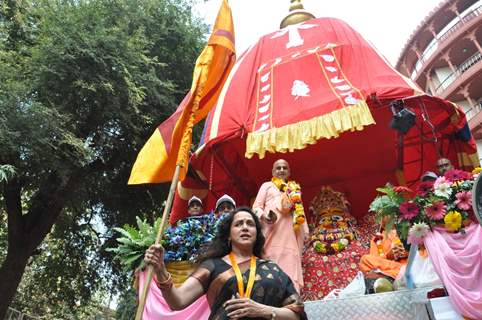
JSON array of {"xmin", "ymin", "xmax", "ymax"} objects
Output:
[{"xmin": 145, "ymin": 207, "xmax": 306, "ymax": 320}]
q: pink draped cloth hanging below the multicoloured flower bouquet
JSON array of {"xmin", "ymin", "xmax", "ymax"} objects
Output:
[{"xmin": 424, "ymin": 223, "xmax": 482, "ymax": 319}]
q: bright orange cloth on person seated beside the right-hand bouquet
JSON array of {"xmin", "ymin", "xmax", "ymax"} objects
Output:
[{"xmin": 360, "ymin": 230, "xmax": 407, "ymax": 279}]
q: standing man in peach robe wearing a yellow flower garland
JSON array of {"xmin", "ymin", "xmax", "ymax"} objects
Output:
[{"xmin": 253, "ymin": 159, "xmax": 308, "ymax": 292}]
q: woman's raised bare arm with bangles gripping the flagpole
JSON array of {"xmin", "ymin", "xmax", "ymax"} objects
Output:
[{"xmin": 144, "ymin": 245, "xmax": 204, "ymax": 310}]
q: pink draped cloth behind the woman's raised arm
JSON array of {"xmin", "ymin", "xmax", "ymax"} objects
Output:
[{"xmin": 139, "ymin": 271, "xmax": 211, "ymax": 320}]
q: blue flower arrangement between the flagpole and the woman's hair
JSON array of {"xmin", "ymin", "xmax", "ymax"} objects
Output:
[{"xmin": 162, "ymin": 214, "xmax": 225, "ymax": 262}]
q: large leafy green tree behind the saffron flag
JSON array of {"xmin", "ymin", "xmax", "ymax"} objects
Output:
[{"xmin": 0, "ymin": 0, "xmax": 206, "ymax": 318}]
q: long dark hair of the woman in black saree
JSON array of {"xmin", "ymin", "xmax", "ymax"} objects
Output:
[{"xmin": 199, "ymin": 206, "xmax": 265, "ymax": 262}]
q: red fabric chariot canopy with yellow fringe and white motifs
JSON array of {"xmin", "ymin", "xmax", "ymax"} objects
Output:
[{"xmin": 171, "ymin": 18, "xmax": 477, "ymax": 222}]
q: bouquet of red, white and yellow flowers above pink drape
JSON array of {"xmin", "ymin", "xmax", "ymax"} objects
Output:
[{"xmin": 370, "ymin": 168, "xmax": 482, "ymax": 244}]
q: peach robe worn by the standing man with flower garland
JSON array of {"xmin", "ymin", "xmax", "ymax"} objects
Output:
[{"xmin": 253, "ymin": 181, "xmax": 308, "ymax": 292}]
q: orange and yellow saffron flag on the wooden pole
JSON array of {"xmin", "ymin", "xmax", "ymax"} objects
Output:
[{"xmin": 128, "ymin": 0, "xmax": 236, "ymax": 184}]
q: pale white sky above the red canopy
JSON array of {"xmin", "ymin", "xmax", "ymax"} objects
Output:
[{"xmin": 195, "ymin": 0, "xmax": 443, "ymax": 65}]
